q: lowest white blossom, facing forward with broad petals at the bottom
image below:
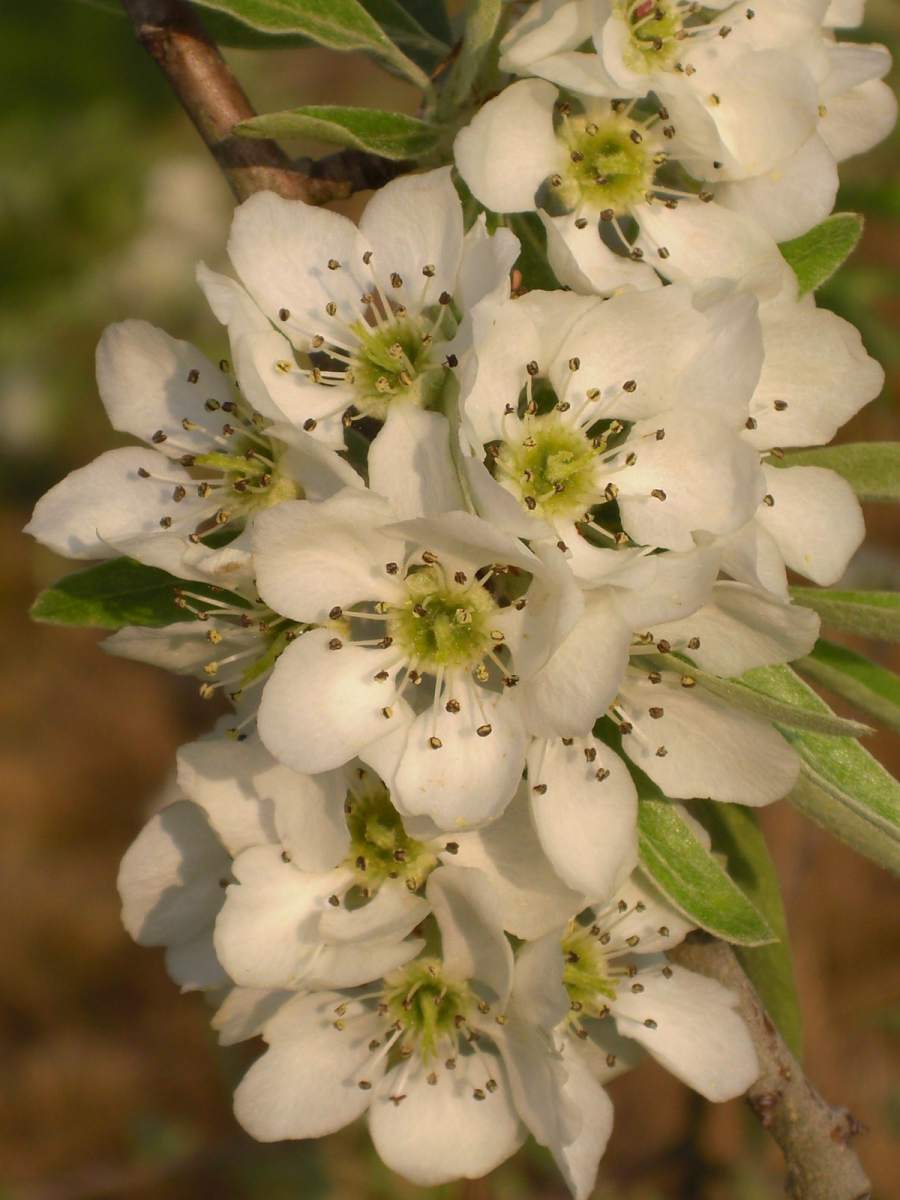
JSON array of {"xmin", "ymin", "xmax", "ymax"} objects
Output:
[{"xmin": 229, "ymin": 868, "xmax": 580, "ymax": 1186}]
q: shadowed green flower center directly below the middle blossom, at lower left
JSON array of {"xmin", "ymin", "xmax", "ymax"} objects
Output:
[{"xmin": 344, "ymin": 769, "xmax": 438, "ymax": 893}]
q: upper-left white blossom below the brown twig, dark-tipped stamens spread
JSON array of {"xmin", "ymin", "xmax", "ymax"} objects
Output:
[{"xmin": 217, "ymin": 168, "xmax": 518, "ymax": 449}]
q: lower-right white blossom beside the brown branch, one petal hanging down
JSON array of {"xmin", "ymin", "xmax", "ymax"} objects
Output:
[{"xmin": 510, "ymin": 872, "xmax": 760, "ymax": 1200}]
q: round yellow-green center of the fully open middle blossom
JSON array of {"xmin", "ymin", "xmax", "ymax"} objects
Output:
[{"xmin": 388, "ymin": 565, "xmax": 503, "ymax": 673}]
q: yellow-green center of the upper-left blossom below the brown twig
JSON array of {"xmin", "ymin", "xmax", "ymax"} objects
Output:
[{"xmin": 350, "ymin": 313, "xmax": 446, "ymax": 421}]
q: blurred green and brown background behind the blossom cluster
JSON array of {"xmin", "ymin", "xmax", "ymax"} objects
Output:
[{"xmin": 0, "ymin": 0, "xmax": 900, "ymax": 1200}]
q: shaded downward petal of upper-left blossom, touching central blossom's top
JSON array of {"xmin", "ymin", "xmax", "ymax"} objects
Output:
[{"xmin": 368, "ymin": 404, "xmax": 466, "ymax": 521}]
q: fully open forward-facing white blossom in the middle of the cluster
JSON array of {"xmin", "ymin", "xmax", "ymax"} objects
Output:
[{"xmin": 254, "ymin": 491, "xmax": 628, "ymax": 829}]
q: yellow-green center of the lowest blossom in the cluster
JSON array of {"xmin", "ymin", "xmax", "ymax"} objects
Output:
[{"xmin": 384, "ymin": 958, "xmax": 475, "ymax": 1063}]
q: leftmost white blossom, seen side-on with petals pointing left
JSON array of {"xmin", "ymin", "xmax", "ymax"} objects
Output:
[{"xmin": 26, "ymin": 320, "xmax": 362, "ymax": 580}]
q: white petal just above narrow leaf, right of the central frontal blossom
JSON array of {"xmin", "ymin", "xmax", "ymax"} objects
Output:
[{"xmin": 652, "ymin": 582, "xmax": 818, "ymax": 676}]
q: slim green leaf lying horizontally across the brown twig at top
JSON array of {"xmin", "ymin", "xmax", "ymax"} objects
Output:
[{"xmin": 234, "ymin": 104, "xmax": 438, "ymax": 160}]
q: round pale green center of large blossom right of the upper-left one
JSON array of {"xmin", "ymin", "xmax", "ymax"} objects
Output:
[{"xmin": 494, "ymin": 413, "xmax": 598, "ymax": 520}]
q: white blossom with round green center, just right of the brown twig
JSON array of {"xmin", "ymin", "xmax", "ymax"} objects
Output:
[{"xmin": 454, "ymin": 79, "xmax": 787, "ymax": 295}]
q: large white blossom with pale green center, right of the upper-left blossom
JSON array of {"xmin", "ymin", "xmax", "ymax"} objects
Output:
[{"xmin": 461, "ymin": 286, "xmax": 764, "ymax": 573}]
